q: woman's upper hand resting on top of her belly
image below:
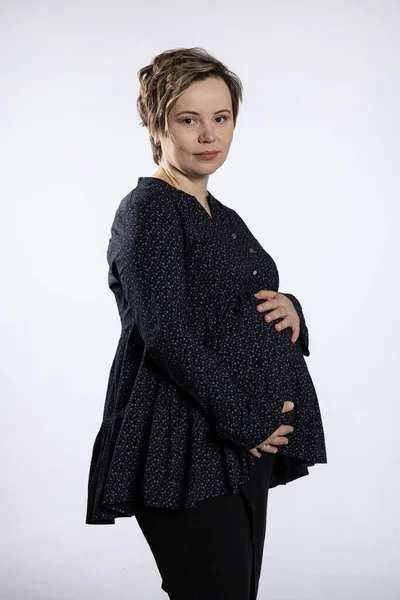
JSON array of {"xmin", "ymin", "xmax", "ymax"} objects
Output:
[{"xmin": 254, "ymin": 290, "xmax": 300, "ymax": 344}]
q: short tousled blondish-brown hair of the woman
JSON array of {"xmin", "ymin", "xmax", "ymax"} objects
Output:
[{"xmin": 136, "ymin": 47, "xmax": 243, "ymax": 165}]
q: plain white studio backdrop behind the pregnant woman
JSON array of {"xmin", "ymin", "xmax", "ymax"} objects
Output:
[{"xmin": 0, "ymin": 0, "xmax": 400, "ymax": 600}]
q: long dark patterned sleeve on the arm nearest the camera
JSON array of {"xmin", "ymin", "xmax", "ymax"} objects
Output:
[{"xmin": 112, "ymin": 196, "xmax": 283, "ymax": 449}]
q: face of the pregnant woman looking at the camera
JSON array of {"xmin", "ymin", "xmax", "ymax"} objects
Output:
[{"xmin": 159, "ymin": 77, "xmax": 233, "ymax": 179}]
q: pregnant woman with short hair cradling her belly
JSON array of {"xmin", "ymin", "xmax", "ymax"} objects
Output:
[{"xmin": 86, "ymin": 48, "xmax": 327, "ymax": 600}]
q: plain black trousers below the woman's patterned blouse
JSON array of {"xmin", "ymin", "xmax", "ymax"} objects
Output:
[{"xmin": 135, "ymin": 453, "xmax": 275, "ymax": 600}]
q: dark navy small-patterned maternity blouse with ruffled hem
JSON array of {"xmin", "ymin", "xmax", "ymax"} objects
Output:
[{"xmin": 86, "ymin": 177, "xmax": 327, "ymax": 524}]
